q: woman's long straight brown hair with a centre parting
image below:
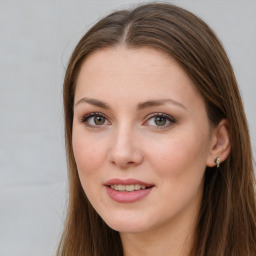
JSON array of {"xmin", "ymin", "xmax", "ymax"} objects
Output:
[{"xmin": 57, "ymin": 3, "xmax": 256, "ymax": 256}]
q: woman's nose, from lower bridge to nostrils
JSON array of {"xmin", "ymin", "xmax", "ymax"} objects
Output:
[{"xmin": 109, "ymin": 123, "xmax": 143, "ymax": 169}]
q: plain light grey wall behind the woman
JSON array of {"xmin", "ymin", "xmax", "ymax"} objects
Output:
[{"xmin": 0, "ymin": 0, "xmax": 256, "ymax": 256}]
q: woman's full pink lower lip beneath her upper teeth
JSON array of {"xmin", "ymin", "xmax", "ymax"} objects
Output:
[{"xmin": 105, "ymin": 186, "xmax": 153, "ymax": 203}]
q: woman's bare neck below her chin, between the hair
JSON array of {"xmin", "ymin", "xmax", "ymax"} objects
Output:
[{"xmin": 120, "ymin": 209, "xmax": 196, "ymax": 256}]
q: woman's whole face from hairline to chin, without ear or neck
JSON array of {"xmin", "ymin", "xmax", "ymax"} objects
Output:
[{"xmin": 72, "ymin": 46, "xmax": 214, "ymax": 233}]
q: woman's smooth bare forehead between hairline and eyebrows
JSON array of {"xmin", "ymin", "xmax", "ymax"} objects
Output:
[{"xmin": 75, "ymin": 46, "xmax": 202, "ymax": 110}]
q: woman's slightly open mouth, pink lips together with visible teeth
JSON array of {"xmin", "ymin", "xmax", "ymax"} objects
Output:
[{"xmin": 104, "ymin": 179, "xmax": 154, "ymax": 203}]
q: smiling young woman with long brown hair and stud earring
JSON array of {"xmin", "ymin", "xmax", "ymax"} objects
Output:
[{"xmin": 58, "ymin": 4, "xmax": 256, "ymax": 256}]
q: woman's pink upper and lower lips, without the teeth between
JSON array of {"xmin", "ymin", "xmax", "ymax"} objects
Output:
[{"xmin": 104, "ymin": 179, "xmax": 154, "ymax": 203}]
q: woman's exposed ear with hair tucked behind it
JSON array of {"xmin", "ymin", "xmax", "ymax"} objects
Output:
[{"xmin": 206, "ymin": 119, "xmax": 231, "ymax": 167}]
